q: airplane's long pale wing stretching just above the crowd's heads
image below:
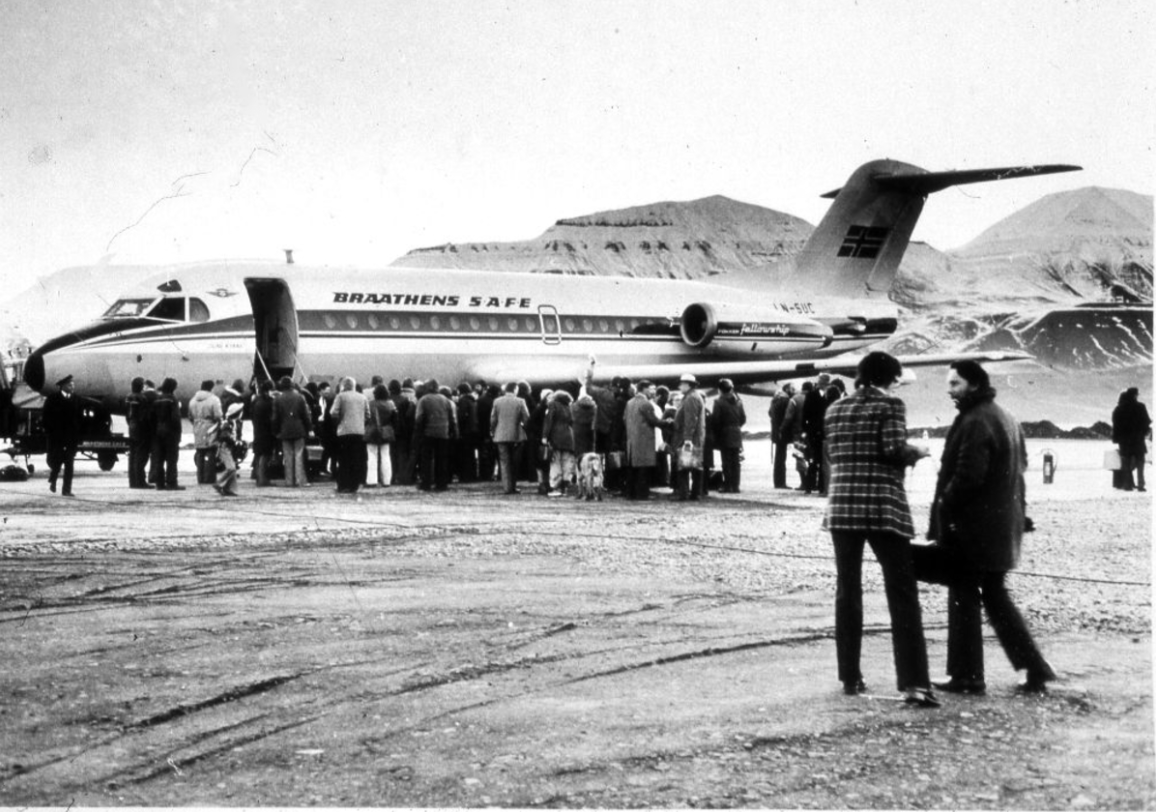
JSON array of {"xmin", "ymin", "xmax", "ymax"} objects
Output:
[{"xmin": 472, "ymin": 352, "xmax": 1033, "ymax": 387}]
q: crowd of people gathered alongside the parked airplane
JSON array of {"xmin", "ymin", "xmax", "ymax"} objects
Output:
[{"xmin": 45, "ymin": 374, "xmax": 747, "ymax": 500}]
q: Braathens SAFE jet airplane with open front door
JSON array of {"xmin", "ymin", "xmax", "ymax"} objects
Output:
[{"xmin": 24, "ymin": 160, "xmax": 1080, "ymax": 413}]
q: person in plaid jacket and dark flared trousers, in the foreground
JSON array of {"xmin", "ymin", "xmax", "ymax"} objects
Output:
[{"xmin": 824, "ymin": 352, "xmax": 940, "ymax": 708}]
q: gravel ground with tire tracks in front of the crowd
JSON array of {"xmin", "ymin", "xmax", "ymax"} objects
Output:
[{"xmin": 0, "ymin": 458, "xmax": 1156, "ymax": 809}]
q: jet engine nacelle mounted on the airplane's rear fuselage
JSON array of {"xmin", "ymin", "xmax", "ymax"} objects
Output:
[{"xmin": 679, "ymin": 302, "xmax": 835, "ymax": 355}]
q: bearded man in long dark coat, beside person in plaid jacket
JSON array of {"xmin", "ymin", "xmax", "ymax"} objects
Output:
[{"xmin": 920, "ymin": 361, "xmax": 1055, "ymax": 694}]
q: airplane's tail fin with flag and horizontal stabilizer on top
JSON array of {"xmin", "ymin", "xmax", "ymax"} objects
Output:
[{"xmin": 794, "ymin": 161, "xmax": 1080, "ymax": 297}]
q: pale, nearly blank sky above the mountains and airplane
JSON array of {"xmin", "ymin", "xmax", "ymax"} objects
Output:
[{"xmin": 0, "ymin": 0, "xmax": 1156, "ymax": 301}]
